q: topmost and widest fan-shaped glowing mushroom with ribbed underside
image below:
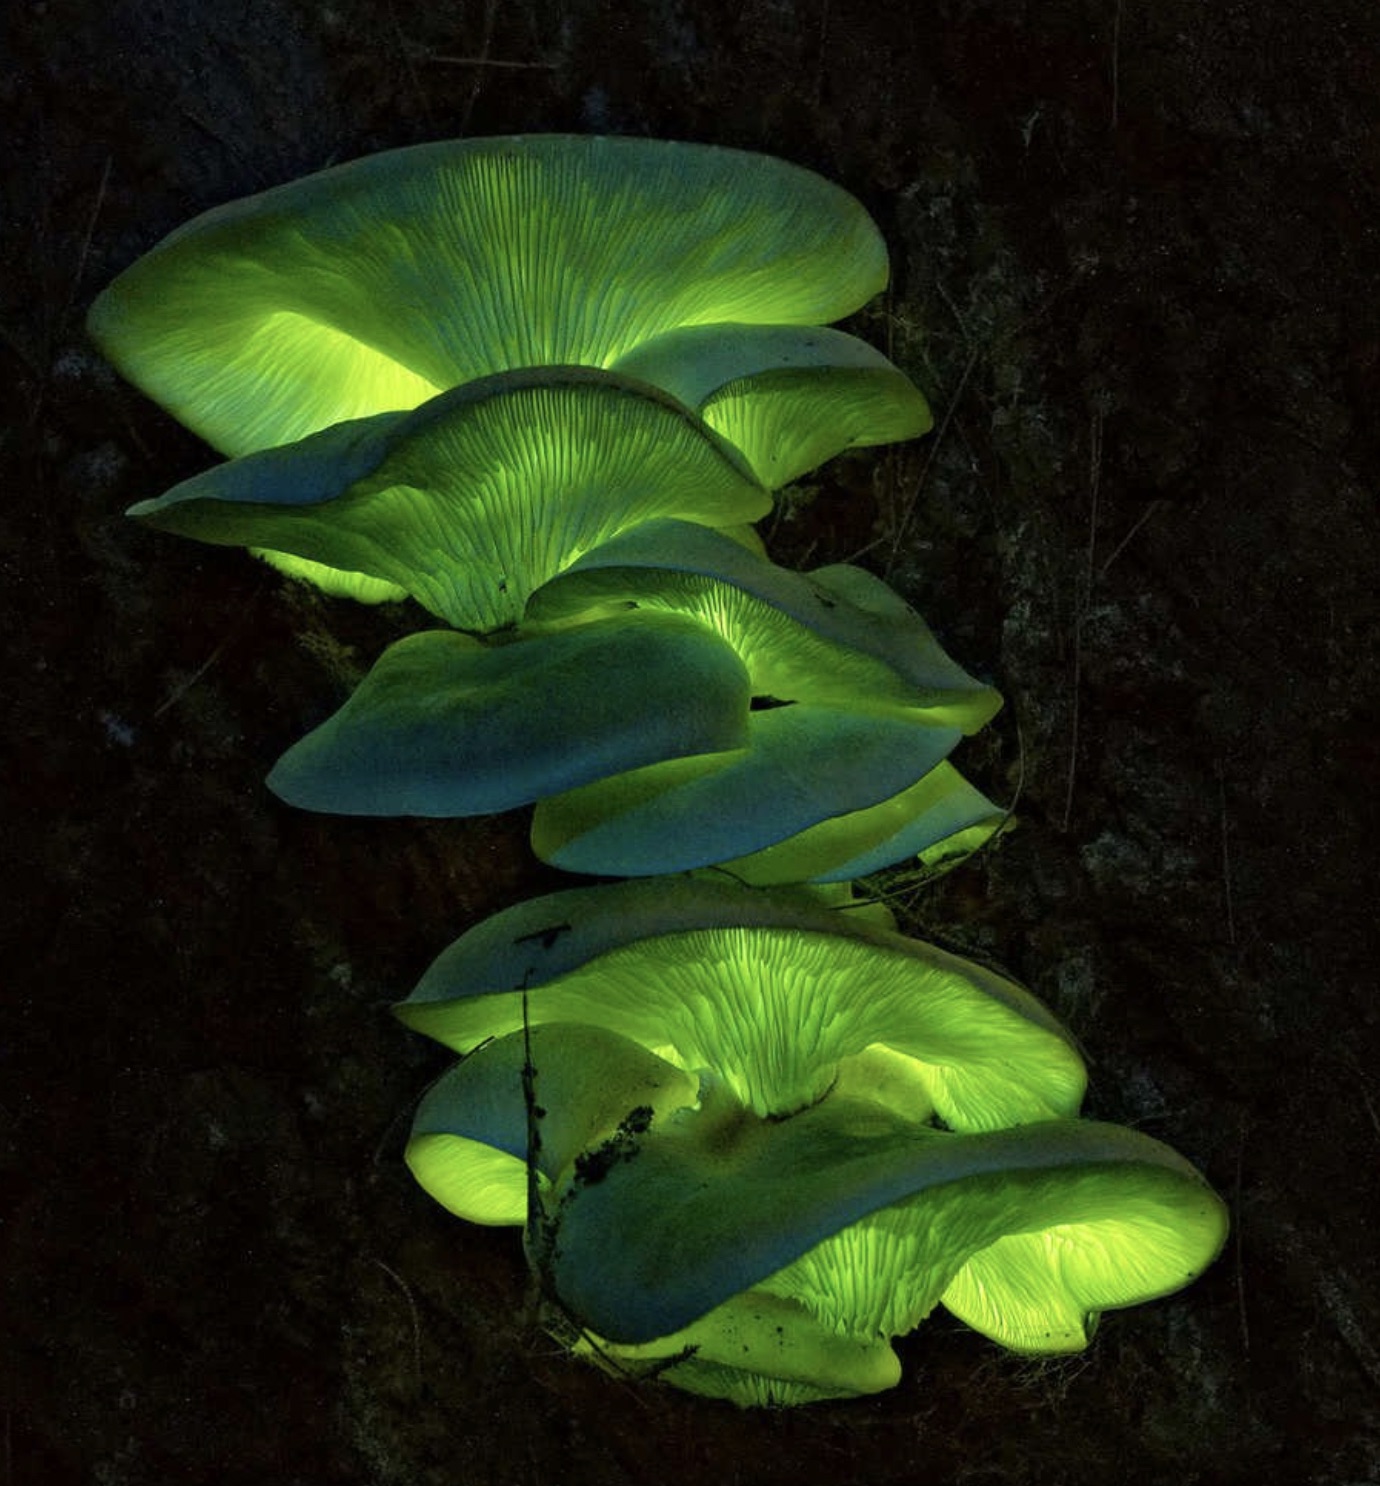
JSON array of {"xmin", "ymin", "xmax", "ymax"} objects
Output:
[{"xmin": 89, "ymin": 134, "xmax": 887, "ymax": 455}]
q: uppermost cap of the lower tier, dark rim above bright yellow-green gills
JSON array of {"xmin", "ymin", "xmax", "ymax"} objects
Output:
[{"xmin": 397, "ymin": 878, "xmax": 1084, "ymax": 1129}]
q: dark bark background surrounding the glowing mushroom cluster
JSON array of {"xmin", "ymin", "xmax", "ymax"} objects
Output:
[{"xmin": 0, "ymin": 0, "xmax": 1380, "ymax": 1486}]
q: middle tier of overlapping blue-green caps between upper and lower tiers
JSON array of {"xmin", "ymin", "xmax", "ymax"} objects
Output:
[{"xmin": 270, "ymin": 520, "xmax": 1003, "ymax": 883}]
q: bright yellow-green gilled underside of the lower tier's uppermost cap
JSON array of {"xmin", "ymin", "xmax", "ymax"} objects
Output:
[{"xmin": 397, "ymin": 884, "xmax": 1083, "ymax": 1131}]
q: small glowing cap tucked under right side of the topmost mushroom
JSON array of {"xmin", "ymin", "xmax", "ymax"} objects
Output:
[{"xmin": 612, "ymin": 325, "xmax": 933, "ymax": 490}]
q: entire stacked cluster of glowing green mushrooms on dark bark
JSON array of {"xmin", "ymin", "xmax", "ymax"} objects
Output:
[{"xmin": 89, "ymin": 135, "xmax": 1226, "ymax": 1403}]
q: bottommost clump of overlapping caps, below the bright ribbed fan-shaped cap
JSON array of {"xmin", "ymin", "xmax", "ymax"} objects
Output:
[{"xmin": 409, "ymin": 1022, "xmax": 1227, "ymax": 1403}]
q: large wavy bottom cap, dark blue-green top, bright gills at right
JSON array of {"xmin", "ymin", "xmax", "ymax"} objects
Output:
[{"xmin": 550, "ymin": 1085, "xmax": 1227, "ymax": 1390}]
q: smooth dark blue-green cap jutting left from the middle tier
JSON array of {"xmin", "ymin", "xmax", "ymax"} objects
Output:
[{"xmin": 269, "ymin": 614, "xmax": 749, "ymax": 816}]
